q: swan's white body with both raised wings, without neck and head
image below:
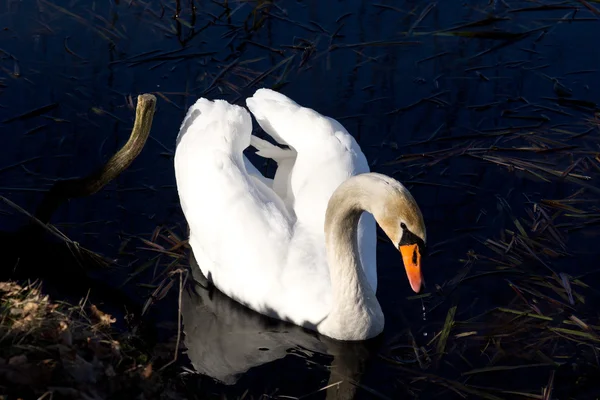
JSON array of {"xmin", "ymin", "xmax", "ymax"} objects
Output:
[{"xmin": 175, "ymin": 89, "xmax": 376, "ymax": 327}]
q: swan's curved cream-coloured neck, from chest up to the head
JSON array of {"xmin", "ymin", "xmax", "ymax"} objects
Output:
[{"xmin": 319, "ymin": 174, "xmax": 384, "ymax": 340}]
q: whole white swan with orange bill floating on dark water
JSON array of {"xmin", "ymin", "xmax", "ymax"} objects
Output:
[{"xmin": 174, "ymin": 88, "xmax": 426, "ymax": 341}]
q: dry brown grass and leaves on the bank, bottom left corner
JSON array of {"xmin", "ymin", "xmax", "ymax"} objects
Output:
[{"xmin": 0, "ymin": 282, "xmax": 180, "ymax": 399}]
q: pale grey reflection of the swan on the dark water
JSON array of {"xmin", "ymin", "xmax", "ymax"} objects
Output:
[{"xmin": 182, "ymin": 256, "xmax": 379, "ymax": 399}]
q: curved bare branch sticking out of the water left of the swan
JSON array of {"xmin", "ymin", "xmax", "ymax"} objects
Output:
[{"xmin": 35, "ymin": 94, "xmax": 156, "ymax": 223}]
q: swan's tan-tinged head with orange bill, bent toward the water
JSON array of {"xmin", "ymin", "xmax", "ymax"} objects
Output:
[{"xmin": 371, "ymin": 174, "xmax": 427, "ymax": 293}]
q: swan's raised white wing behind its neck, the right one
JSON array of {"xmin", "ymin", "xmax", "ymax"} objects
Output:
[{"xmin": 246, "ymin": 89, "xmax": 377, "ymax": 290}]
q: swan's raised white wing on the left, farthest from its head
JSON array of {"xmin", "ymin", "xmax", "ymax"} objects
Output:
[{"xmin": 175, "ymin": 99, "xmax": 293, "ymax": 312}]
